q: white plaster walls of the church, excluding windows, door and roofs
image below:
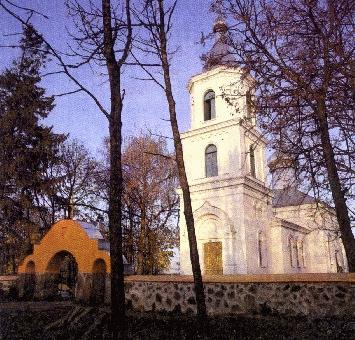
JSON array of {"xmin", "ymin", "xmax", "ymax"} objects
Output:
[{"xmin": 179, "ymin": 63, "xmax": 345, "ymax": 274}]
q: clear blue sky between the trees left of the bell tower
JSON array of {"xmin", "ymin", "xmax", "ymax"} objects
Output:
[{"xmin": 0, "ymin": 0, "xmax": 214, "ymax": 152}]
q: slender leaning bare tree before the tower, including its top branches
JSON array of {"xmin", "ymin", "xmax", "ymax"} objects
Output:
[{"xmin": 133, "ymin": 0, "xmax": 207, "ymax": 319}]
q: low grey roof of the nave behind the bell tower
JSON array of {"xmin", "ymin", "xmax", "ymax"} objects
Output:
[{"xmin": 272, "ymin": 187, "xmax": 317, "ymax": 208}]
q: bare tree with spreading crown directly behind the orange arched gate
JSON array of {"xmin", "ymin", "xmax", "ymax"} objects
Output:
[{"xmin": 36, "ymin": 140, "xmax": 105, "ymax": 225}]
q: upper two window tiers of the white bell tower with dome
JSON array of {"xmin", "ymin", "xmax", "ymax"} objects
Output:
[{"xmin": 182, "ymin": 20, "xmax": 266, "ymax": 185}]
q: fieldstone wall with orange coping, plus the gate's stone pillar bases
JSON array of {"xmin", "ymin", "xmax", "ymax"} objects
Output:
[{"xmin": 19, "ymin": 273, "xmax": 355, "ymax": 317}]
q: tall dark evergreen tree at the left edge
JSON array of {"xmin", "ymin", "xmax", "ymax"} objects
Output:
[{"xmin": 0, "ymin": 26, "xmax": 64, "ymax": 271}]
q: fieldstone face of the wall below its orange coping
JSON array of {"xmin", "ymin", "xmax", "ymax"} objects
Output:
[{"xmin": 126, "ymin": 282, "xmax": 355, "ymax": 316}]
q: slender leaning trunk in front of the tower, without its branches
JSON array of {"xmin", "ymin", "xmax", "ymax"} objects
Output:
[{"xmin": 159, "ymin": 0, "xmax": 207, "ymax": 319}]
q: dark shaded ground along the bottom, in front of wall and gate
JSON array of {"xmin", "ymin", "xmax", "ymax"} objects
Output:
[{"xmin": 0, "ymin": 302, "xmax": 355, "ymax": 340}]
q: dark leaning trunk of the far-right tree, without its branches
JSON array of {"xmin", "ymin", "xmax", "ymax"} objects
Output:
[{"xmin": 317, "ymin": 99, "xmax": 355, "ymax": 273}]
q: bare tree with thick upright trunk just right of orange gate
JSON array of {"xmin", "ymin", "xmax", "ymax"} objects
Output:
[{"xmin": 0, "ymin": 0, "xmax": 132, "ymax": 338}]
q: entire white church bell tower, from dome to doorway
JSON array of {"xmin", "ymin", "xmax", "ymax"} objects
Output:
[{"xmin": 179, "ymin": 20, "xmax": 271, "ymax": 274}]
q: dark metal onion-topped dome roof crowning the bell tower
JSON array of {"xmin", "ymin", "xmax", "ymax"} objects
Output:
[{"xmin": 202, "ymin": 20, "xmax": 237, "ymax": 71}]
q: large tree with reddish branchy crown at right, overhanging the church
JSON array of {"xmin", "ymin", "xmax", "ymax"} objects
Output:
[{"xmin": 212, "ymin": 0, "xmax": 355, "ymax": 272}]
